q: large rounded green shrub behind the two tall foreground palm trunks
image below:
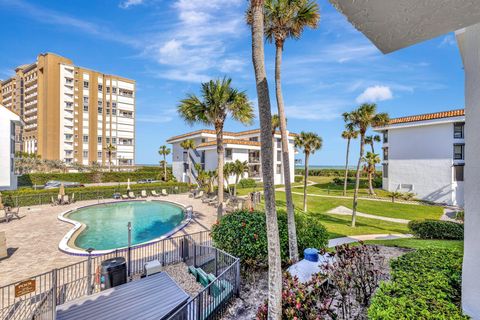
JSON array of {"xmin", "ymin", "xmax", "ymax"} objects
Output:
[{"xmin": 212, "ymin": 211, "xmax": 328, "ymax": 268}]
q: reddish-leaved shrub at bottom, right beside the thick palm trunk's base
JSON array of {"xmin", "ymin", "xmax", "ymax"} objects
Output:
[{"xmin": 257, "ymin": 272, "xmax": 336, "ymax": 320}]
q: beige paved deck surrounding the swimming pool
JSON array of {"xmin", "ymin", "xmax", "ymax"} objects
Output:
[{"xmin": 0, "ymin": 194, "xmax": 217, "ymax": 287}]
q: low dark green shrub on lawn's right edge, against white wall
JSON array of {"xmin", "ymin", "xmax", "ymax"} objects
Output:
[{"xmin": 408, "ymin": 220, "xmax": 463, "ymax": 240}]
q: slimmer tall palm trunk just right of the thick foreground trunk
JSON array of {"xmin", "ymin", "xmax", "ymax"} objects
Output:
[{"xmin": 275, "ymin": 43, "xmax": 298, "ymax": 262}]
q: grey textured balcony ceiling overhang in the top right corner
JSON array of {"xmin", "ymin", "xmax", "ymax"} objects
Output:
[{"xmin": 329, "ymin": 0, "xmax": 480, "ymax": 53}]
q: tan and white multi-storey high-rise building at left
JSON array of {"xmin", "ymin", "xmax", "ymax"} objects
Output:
[{"xmin": 0, "ymin": 53, "xmax": 135, "ymax": 166}]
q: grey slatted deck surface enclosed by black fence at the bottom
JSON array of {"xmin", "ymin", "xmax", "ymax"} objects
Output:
[{"xmin": 57, "ymin": 272, "xmax": 190, "ymax": 320}]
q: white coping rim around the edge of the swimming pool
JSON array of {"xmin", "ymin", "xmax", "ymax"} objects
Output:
[{"xmin": 57, "ymin": 199, "xmax": 193, "ymax": 256}]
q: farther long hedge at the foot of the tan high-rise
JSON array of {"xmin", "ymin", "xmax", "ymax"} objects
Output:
[{"xmin": 18, "ymin": 168, "xmax": 172, "ymax": 187}]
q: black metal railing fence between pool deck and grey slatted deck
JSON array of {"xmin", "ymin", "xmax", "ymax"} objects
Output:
[{"xmin": 0, "ymin": 231, "xmax": 240, "ymax": 320}]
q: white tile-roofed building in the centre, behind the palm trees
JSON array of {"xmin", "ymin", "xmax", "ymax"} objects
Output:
[{"xmin": 167, "ymin": 129, "xmax": 295, "ymax": 184}]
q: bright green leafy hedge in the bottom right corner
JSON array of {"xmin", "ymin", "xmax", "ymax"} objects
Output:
[{"xmin": 368, "ymin": 249, "xmax": 468, "ymax": 320}]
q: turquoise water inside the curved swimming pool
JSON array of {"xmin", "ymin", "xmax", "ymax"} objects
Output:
[{"xmin": 68, "ymin": 201, "xmax": 184, "ymax": 250}]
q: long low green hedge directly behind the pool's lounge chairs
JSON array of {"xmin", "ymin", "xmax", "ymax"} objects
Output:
[{"xmin": 2, "ymin": 182, "xmax": 190, "ymax": 207}]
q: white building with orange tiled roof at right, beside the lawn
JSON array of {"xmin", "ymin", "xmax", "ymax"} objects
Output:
[{"xmin": 374, "ymin": 109, "xmax": 465, "ymax": 206}]
